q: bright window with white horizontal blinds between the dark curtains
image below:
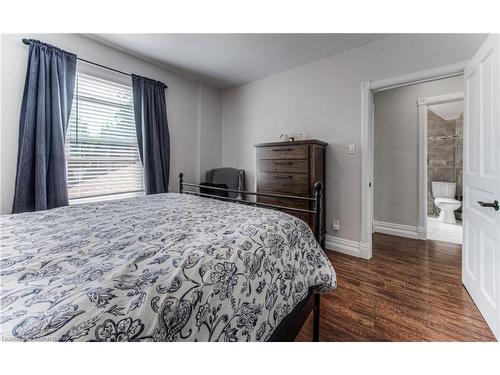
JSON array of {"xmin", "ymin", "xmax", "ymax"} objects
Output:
[{"xmin": 66, "ymin": 73, "xmax": 144, "ymax": 203}]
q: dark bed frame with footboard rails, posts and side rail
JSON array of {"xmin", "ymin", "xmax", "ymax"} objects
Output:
[{"xmin": 179, "ymin": 173, "xmax": 323, "ymax": 342}]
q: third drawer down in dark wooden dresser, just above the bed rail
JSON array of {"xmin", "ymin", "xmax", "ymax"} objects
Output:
[{"xmin": 257, "ymin": 172, "xmax": 310, "ymax": 196}]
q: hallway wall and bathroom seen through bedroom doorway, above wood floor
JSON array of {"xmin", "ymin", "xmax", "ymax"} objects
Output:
[{"xmin": 373, "ymin": 75, "xmax": 463, "ymax": 243}]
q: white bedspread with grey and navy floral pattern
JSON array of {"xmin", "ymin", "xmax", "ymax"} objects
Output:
[{"xmin": 0, "ymin": 193, "xmax": 336, "ymax": 341}]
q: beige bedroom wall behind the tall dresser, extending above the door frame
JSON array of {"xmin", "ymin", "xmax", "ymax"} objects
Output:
[{"xmin": 222, "ymin": 34, "xmax": 486, "ymax": 241}]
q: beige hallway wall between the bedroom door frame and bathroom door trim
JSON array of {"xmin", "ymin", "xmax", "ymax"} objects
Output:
[{"xmin": 373, "ymin": 76, "xmax": 463, "ymax": 227}]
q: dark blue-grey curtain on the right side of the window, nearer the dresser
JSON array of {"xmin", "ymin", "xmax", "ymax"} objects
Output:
[{"xmin": 132, "ymin": 74, "xmax": 170, "ymax": 194}]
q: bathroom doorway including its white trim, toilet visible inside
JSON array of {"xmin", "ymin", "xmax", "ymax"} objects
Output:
[{"xmin": 418, "ymin": 92, "xmax": 464, "ymax": 244}]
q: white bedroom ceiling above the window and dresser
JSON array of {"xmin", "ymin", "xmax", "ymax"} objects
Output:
[{"xmin": 88, "ymin": 34, "xmax": 388, "ymax": 89}]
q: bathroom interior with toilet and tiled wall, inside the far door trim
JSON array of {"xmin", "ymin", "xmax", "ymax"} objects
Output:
[{"xmin": 427, "ymin": 100, "xmax": 463, "ymax": 243}]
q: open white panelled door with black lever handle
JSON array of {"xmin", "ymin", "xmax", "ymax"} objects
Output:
[{"xmin": 462, "ymin": 35, "xmax": 500, "ymax": 340}]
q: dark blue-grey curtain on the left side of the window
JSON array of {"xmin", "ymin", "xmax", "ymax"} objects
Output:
[{"xmin": 12, "ymin": 40, "xmax": 76, "ymax": 213}]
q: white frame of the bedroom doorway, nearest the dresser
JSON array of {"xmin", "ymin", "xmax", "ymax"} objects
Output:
[{"xmin": 359, "ymin": 60, "xmax": 469, "ymax": 259}]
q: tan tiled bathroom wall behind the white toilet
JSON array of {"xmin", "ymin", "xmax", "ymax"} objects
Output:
[{"xmin": 427, "ymin": 110, "xmax": 463, "ymax": 218}]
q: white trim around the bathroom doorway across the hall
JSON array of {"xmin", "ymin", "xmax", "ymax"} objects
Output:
[{"xmin": 417, "ymin": 92, "xmax": 464, "ymax": 240}]
